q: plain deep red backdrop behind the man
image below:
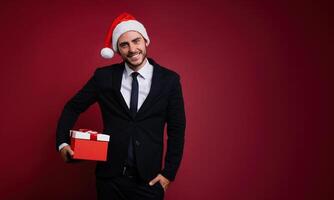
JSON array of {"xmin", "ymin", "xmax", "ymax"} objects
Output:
[{"xmin": 0, "ymin": 0, "xmax": 334, "ymax": 200}]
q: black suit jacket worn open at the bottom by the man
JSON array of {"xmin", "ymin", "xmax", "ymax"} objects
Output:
[{"xmin": 56, "ymin": 59, "xmax": 185, "ymax": 181}]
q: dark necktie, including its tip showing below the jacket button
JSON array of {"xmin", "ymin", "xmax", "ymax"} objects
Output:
[{"xmin": 128, "ymin": 72, "xmax": 139, "ymax": 166}]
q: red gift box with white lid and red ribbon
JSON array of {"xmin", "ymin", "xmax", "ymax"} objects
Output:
[{"xmin": 70, "ymin": 129, "xmax": 110, "ymax": 161}]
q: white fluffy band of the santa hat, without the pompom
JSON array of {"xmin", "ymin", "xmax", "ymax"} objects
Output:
[{"xmin": 112, "ymin": 20, "xmax": 150, "ymax": 52}]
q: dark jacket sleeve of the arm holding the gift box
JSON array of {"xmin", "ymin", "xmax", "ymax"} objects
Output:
[{"xmin": 56, "ymin": 71, "xmax": 98, "ymax": 151}]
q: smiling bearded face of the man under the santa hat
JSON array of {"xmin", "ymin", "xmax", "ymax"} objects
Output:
[{"xmin": 117, "ymin": 31, "xmax": 147, "ymax": 68}]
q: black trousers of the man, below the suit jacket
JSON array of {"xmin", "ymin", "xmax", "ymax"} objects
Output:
[{"xmin": 96, "ymin": 168, "xmax": 164, "ymax": 200}]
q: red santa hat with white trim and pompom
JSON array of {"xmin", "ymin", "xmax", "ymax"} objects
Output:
[{"xmin": 101, "ymin": 13, "xmax": 150, "ymax": 59}]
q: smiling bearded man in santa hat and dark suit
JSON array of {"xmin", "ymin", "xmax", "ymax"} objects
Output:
[{"xmin": 56, "ymin": 13, "xmax": 185, "ymax": 200}]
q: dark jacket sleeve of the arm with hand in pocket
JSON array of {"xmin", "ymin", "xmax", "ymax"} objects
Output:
[{"xmin": 161, "ymin": 76, "xmax": 186, "ymax": 181}]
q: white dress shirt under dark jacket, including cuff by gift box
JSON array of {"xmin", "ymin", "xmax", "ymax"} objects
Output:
[{"xmin": 58, "ymin": 59, "xmax": 153, "ymax": 151}]
